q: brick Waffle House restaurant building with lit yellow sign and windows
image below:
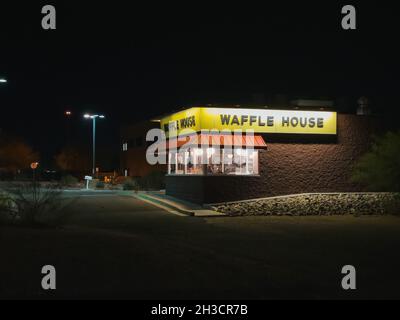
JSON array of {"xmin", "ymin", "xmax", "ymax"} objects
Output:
[{"xmin": 146, "ymin": 107, "xmax": 384, "ymax": 204}]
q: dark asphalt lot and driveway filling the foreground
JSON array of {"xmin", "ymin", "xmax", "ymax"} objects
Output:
[{"xmin": 0, "ymin": 192, "xmax": 400, "ymax": 299}]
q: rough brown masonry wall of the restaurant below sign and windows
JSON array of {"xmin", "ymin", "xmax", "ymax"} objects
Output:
[{"xmin": 166, "ymin": 114, "xmax": 394, "ymax": 203}]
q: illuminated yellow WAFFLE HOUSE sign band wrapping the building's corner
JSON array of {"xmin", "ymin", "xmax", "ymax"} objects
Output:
[{"xmin": 161, "ymin": 108, "xmax": 337, "ymax": 136}]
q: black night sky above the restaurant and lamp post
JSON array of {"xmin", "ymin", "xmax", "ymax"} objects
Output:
[{"xmin": 0, "ymin": 1, "xmax": 400, "ymax": 166}]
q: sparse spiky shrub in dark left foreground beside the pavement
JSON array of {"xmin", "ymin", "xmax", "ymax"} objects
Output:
[{"xmin": 7, "ymin": 183, "xmax": 61, "ymax": 226}]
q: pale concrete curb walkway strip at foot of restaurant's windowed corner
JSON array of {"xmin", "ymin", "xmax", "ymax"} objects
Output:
[{"xmin": 133, "ymin": 191, "xmax": 226, "ymax": 218}]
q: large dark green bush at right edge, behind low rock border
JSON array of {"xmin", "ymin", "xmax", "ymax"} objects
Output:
[{"xmin": 352, "ymin": 131, "xmax": 400, "ymax": 192}]
